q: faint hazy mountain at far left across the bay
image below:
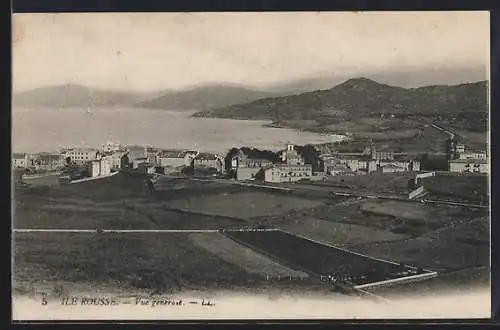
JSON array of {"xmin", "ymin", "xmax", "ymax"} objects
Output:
[{"xmin": 12, "ymin": 84, "xmax": 160, "ymax": 108}]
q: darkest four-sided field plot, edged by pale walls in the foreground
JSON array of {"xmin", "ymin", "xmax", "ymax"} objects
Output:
[{"xmin": 226, "ymin": 231, "xmax": 430, "ymax": 285}]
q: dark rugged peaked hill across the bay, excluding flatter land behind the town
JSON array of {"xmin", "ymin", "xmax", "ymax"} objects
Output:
[{"xmin": 195, "ymin": 77, "xmax": 488, "ymax": 133}]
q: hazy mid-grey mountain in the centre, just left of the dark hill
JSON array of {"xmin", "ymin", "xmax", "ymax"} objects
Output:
[{"xmin": 136, "ymin": 85, "xmax": 283, "ymax": 111}]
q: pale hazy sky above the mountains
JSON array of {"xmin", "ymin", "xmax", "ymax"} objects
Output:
[{"xmin": 13, "ymin": 12, "xmax": 489, "ymax": 91}]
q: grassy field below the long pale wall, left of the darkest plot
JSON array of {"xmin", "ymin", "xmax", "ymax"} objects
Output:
[{"xmin": 13, "ymin": 233, "xmax": 326, "ymax": 294}]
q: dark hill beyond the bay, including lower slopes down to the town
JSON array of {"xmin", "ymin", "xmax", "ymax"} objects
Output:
[{"xmin": 194, "ymin": 77, "xmax": 488, "ymax": 151}]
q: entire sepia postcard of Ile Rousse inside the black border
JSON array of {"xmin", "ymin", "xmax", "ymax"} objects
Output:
[{"xmin": 11, "ymin": 11, "xmax": 491, "ymax": 321}]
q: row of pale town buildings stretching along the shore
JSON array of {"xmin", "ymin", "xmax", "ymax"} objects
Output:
[{"xmin": 12, "ymin": 132, "xmax": 488, "ymax": 188}]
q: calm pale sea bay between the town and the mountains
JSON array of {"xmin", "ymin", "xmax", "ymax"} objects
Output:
[{"xmin": 12, "ymin": 108, "xmax": 343, "ymax": 153}]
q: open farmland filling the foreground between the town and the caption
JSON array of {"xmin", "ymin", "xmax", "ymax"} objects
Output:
[{"xmin": 13, "ymin": 174, "xmax": 489, "ymax": 293}]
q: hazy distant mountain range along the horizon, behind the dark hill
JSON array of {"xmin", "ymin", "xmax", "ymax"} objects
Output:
[{"xmin": 13, "ymin": 67, "xmax": 486, "ymax": 111}]
